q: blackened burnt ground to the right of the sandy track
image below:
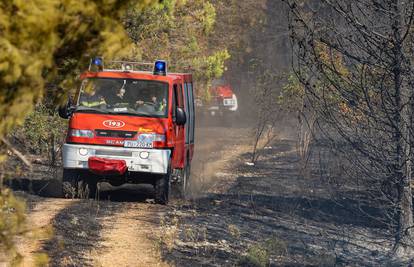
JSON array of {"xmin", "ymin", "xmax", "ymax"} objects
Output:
[{"xmin": 158, "ymin": 140, "xmax": 409, "ymax": 266}]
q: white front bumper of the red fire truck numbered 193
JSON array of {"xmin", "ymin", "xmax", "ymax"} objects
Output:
[{"xmin": 62, "ymin": 144, "xmax": 171, "ymax": 174}]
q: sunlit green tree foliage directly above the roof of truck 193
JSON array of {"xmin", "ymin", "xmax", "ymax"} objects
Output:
[{"xmin": 124, "ymin": 0, "xmax": 230, "ymax": 94}]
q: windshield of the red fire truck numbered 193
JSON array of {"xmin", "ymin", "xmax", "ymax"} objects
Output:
[{"xmin": 76, "ymin": 78, "xmax": 168, "ymax": 117}]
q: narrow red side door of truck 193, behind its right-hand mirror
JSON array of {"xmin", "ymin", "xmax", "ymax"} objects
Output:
[{"xmin": 172, "ymin": 83, "xmax": 185, "ymax": 168}]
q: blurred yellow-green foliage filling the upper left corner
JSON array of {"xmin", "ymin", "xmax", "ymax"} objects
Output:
[{"xmin": 0, "ymin": 0, "xmax": 149, "ymax": 136}]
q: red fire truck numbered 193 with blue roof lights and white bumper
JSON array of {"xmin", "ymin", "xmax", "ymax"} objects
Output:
[{"xmin": 59, "ymin": 58, "xmax": 195, "ymax": 204}]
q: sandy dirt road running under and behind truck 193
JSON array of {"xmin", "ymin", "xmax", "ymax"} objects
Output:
[{"xmin": 12, "ymin": 127, "xmax": 248, "ymax": 266}]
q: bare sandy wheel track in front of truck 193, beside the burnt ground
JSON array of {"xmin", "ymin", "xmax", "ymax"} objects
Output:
[{"xmin": 90, "ymin": 203, "xmax": 169, "ymax": 267}]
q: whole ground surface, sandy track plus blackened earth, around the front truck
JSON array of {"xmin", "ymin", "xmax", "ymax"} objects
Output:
[{"xmin": 4, "ymin": 127, "xmax": 409, "ymax": 266}]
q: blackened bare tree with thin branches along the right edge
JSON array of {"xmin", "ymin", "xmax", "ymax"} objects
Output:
[{"xmin": 288, "ymin": 0, "xmax": 414, "ymax": 252}]
